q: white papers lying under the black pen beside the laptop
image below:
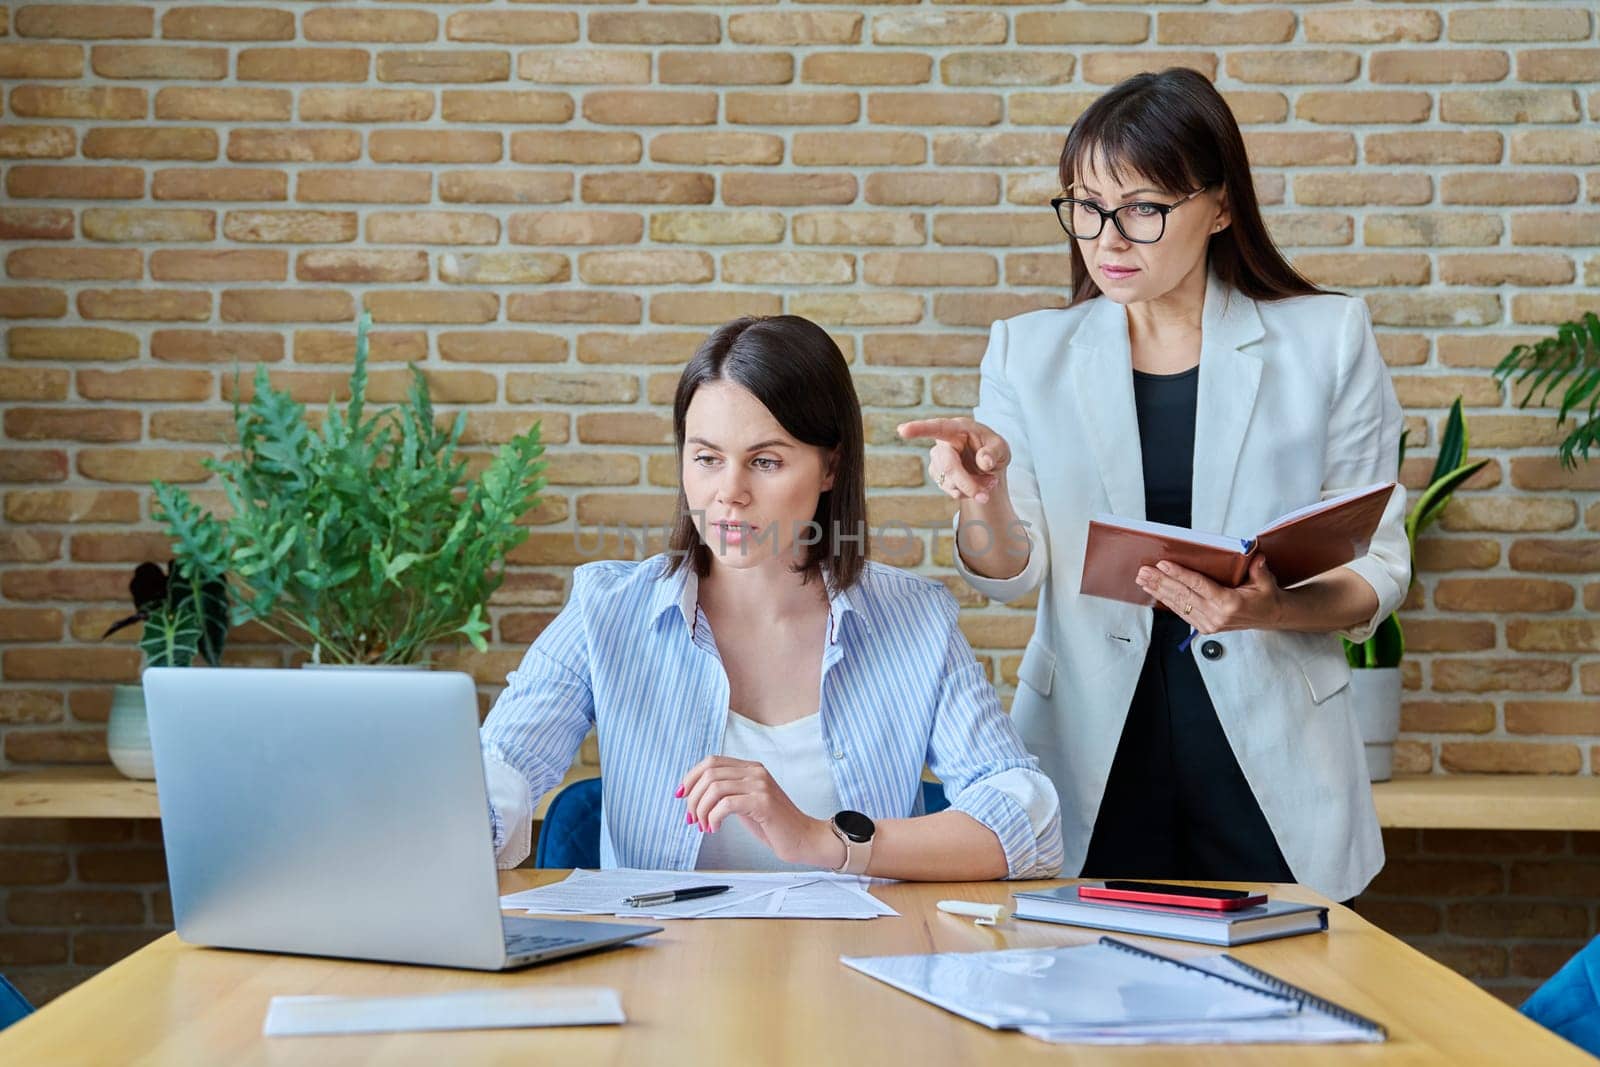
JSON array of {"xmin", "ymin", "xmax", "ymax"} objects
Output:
[{"xmin": 501, "ymin": 869, "xmax": 898, "ymax": 918}]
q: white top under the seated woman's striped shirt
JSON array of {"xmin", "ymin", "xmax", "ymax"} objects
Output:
[{"xmin": 694, "ymin": 707, "xmax": 843, "ymax": 870}]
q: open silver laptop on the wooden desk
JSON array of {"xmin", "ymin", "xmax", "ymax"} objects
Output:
[{"xmin": 144, "ymin": 667, "xmax": 661, "ymax": 971}]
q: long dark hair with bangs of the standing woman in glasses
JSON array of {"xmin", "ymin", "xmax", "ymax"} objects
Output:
[{"xmin": 1061, "ymin": 67, "xmax": 1326, "ymax": 307}]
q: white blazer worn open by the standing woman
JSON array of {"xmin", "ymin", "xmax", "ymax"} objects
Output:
[{"xmin": 957, "ymin": 274, "xmax": 1411, "ymax": 901}]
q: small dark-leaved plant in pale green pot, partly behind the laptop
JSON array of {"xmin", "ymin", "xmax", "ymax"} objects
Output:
[{"xmin": 101, "ymin": 563, "xmax": 230, "ymax": 779}]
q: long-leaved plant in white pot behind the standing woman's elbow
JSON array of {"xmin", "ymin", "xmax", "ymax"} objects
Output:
[{"xmin": 1341, "ymin": 397, "xmax": 1488, "ymax": 782}]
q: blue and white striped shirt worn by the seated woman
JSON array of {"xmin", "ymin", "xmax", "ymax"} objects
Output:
[{"xmin": 482, "ymin": 555, "xmax": 1062, "ymax": 878}]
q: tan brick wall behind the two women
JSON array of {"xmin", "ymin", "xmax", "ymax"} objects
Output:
[{"xmin": 0, "ymin": 2, "xmax": 1600, "ymax": 997}]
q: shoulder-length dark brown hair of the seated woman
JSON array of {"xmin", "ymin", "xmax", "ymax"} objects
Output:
[{"xmin": 667, "ymin": 315, "xmax": 867, "ymax": 592}]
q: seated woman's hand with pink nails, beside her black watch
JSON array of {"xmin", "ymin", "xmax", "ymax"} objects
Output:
[{"xmin": 678, "ymin": 755, "xmax": 845, "ymax": 867}]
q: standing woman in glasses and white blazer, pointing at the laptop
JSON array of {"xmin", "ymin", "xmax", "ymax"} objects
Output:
[{"xmin": 901, "ymin": 70, "xmax": 1410, "ymax": 901}]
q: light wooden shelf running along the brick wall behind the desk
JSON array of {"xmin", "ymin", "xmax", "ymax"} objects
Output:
[{"xmin": 12, "ymin": 766, "xmax": 1600, "ymax": 830}]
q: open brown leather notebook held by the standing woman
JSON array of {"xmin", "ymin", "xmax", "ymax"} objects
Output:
[{"xmin": 1078, "ymin": 482, "xmax": 1395, "ymax": 605}]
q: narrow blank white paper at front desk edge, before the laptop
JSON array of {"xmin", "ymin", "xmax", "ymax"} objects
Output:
[{"xmin": 261, "ymin": 987, "xmax": 626, "ymax": 1037}]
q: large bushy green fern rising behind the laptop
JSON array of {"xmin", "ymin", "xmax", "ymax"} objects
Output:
[{"xmin": 155, "ymin": 314, "xmax": 544, "ymax": 665}]
